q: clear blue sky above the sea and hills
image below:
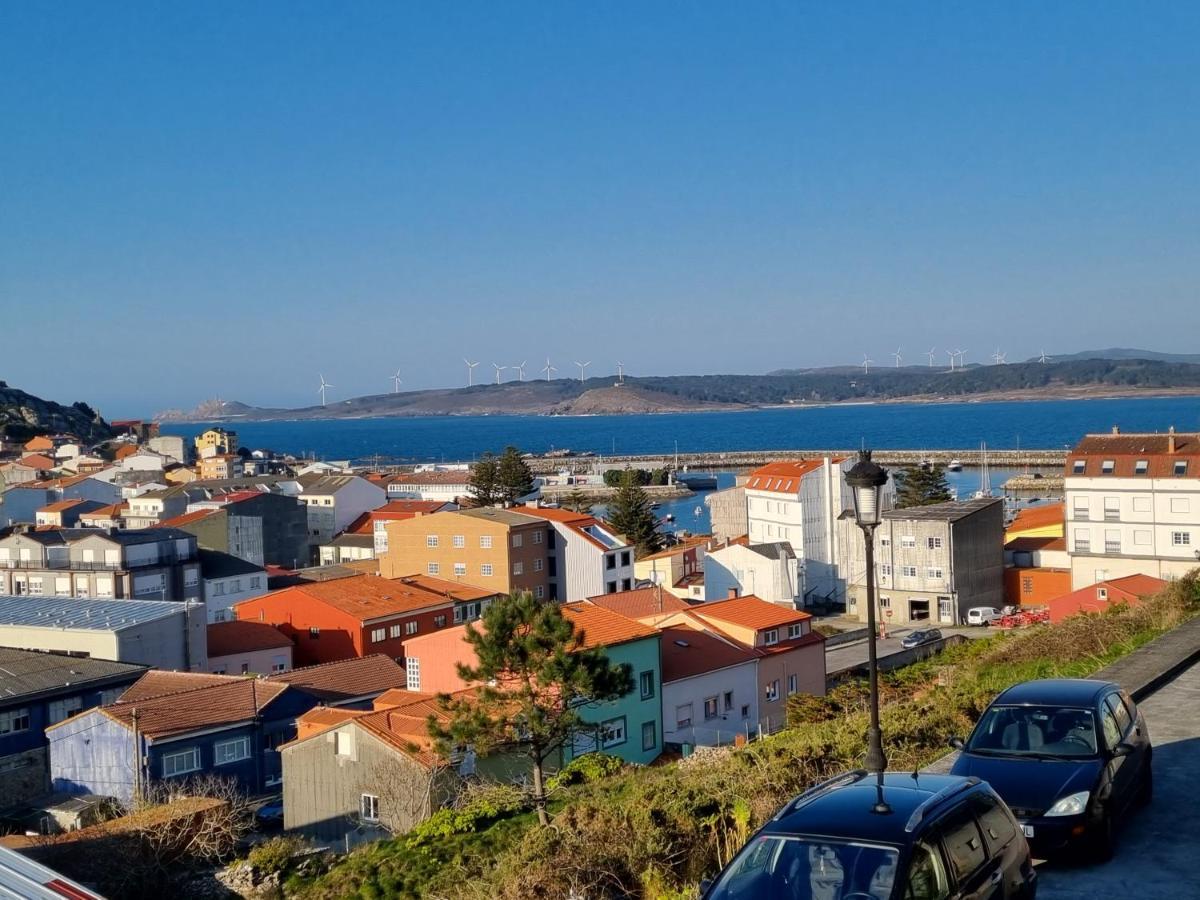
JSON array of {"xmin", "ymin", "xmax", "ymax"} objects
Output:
[{"xmin": 0, "ymin": 2, "xmax": 1200, "ymax": 415}]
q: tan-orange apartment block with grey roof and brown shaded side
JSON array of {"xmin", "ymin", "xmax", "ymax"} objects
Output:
[{"xmin": 379, "ymin": 506, "xmax": 550, "ymax": 599}]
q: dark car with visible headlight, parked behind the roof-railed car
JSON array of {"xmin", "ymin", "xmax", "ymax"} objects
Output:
[{"xmin": 952, "ymin": 678, "xmax": 1153, "ymax": 859}]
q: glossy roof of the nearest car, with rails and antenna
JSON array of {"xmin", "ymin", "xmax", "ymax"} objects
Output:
[{"xmin": 762, "ymin": 770, "xmax": 979, "ymax": 844}]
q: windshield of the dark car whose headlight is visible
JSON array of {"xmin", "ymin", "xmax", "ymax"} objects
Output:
[{"xmin": 966, "ymin": 706, "xmax": 1097, "ymax": 760}]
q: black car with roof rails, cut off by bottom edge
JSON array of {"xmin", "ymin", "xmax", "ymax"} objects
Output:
[{"xmin": 701, "ymin": 772, "xmax": 1037, "ymax": 900}]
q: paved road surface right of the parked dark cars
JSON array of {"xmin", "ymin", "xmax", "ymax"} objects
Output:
[{"xmin": 1038, "ymin": 665, "xmax": 1200, "ymax": 900}]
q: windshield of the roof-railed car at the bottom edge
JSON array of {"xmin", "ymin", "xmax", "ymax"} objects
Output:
[{"xmin": 708, "ymin": 834, "xmax": 899, "ymax": 900}]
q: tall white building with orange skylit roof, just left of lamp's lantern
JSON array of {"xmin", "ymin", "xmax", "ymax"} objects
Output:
[{"xmin": 745, "ymin": 457, "xmax": 895, "ymax": 605}]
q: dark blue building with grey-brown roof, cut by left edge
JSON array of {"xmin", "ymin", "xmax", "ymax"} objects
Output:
[{"xmin": 0, "ymin": 652, "xmax": 145, "ymax": 806}]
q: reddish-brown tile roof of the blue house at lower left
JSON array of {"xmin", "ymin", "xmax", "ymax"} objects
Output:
[{"xmin": 93, "ymin": 678, "xmax": 288, "ymax": 738}]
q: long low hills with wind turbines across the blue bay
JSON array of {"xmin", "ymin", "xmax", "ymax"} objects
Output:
[{"xmin": 158, "ymin": 359, "xmax": 1200, "ymax": 421}]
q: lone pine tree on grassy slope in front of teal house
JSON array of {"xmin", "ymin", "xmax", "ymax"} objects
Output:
[{"xmin": 428, "ymin": 592, "xmax": 634, "ymax": 824}]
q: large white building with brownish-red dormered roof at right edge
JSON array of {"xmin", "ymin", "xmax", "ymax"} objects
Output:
[{"xmin": 1064, "ymin": 428, "xmax": 1200, "ymax": 590}]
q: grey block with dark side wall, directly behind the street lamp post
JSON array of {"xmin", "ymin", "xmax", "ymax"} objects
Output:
[{"xmin": 840, "ymin": 497, "xmax": 1004, "ymax": 625}]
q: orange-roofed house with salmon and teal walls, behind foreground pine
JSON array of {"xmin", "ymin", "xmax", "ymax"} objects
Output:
[{"xmin": 404, "ymin": 602, "xmax": 662, "ymax": 764}]
